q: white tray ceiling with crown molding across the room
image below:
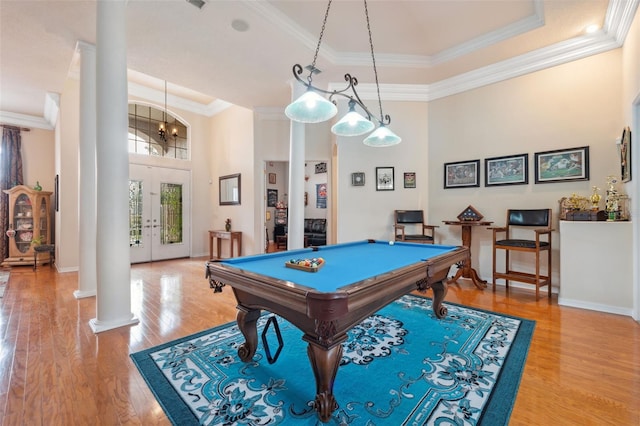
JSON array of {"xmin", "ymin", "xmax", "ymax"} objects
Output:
[{"xmin": 0, "ymin": 0, "xmax": 640, "ymax": 130}]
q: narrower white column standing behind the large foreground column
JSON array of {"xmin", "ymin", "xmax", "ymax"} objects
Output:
[{"xmin": 73, "ymin": 41, "xmax": 97, "ymax": 299}]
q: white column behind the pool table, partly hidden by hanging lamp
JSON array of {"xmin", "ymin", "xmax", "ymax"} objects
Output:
[{"xmin": 287, "ymin": 81, "xmax": 306, "ymax": 250}]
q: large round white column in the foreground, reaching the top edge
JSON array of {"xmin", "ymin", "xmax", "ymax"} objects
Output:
[{"xmin": 89, "ymin": 0, "xmax": 138, "ymax": 333}]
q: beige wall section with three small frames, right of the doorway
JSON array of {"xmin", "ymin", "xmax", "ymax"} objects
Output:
[{"xmin": 337, "ymin": 98, "xmax": 430, "ymax": 242}]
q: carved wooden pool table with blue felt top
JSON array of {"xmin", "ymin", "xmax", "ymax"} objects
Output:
[{"xmin": 206, "ymin": 240, "xmax": 469, "ymax": 422}]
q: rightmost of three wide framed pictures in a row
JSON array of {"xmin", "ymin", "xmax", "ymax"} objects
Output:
[{"xmin": 534, "ymin": 146, "xmax": 589, "ymax": 183}]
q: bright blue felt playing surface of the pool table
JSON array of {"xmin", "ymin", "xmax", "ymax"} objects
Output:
[{"xmin": 220, "ymin": 240, "xmax": 458, "ymax": 293}]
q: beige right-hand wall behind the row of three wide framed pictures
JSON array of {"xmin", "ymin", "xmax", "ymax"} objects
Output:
[{"xmin": 429, "ymin": 49, "xmax": 623, "ymax": 286}]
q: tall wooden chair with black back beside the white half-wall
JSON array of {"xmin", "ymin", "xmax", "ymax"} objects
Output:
[{"xmin": 488, "ymin": 209, "xmax": 553, "ymax": 300}]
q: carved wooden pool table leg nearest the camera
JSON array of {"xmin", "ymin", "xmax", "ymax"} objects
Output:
[{"xmin": 304, "ymin": 335, "xmax": 347, "ymax": 422}]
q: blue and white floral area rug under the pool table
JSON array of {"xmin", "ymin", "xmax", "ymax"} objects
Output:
[{"xmin": 131, "ymin": 295, "xmax": 535, "ymax": 426}]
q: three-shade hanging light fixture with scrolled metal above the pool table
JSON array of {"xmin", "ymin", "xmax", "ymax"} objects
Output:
[{"xmin": 284, "ymin": 0, "xmax": 402, "ymax": 147}]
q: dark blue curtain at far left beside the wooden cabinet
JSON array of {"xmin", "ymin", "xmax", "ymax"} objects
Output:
[{"xmin": 0, "ymin": 126, "xmax": 23, "ymax": 260}]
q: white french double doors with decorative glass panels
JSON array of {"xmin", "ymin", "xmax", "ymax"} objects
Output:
[{"xmin": 129, "ymin": 164, "xmax": 191, "ymax": 263}]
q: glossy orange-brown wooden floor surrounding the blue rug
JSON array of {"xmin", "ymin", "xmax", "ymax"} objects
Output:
[{"xmin": 0, "ymin": 258, "xmax": 640, "ymax": 426}]
